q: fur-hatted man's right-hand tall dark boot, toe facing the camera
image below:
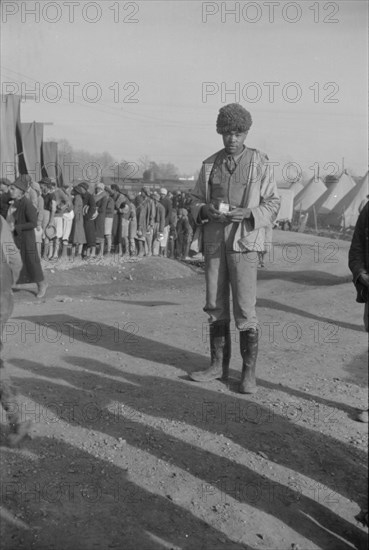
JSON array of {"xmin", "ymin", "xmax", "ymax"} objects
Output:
[{"xmin": 239, "ymin": 329, "xmax": 259, "ymax": 393}]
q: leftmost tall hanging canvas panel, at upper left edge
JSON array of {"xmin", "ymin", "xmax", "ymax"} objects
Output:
[{"xmin": 0, "ymin": 94, "xmax": 21, "ymax": 181}]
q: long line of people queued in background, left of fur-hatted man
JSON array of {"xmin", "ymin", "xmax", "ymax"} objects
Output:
[{"xmin": 0, "ymin": 175, "xmax": 195, "ymax": 261}]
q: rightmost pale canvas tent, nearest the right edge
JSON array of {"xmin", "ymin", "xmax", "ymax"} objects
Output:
[{"xmin": 326, "ymin": 172, "xmax": 369, "ymax": 228}]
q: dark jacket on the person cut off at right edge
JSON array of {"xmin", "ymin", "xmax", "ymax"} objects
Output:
[{"xmin": 349, "ymin": 203, "xmax": 369, "ymax": 303}]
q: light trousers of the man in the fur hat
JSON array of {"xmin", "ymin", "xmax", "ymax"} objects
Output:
[{"xmin": 204, "ymin": 243, "xmax": 258, "ymax": 330}]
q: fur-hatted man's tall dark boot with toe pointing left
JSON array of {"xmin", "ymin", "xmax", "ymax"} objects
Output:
[{"xmin": 189, "ymin": 322, "xmax": 229, "ymax": 382}]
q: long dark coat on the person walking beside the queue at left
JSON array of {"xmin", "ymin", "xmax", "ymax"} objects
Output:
[{"xmin": 13, "ymin": 197, "xmax": 44, "ymax": 284}]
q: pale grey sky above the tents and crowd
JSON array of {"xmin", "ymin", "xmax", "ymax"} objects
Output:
[{"xmin": 1, "ymin": 0, "xmax": 368, "ymax": 179}]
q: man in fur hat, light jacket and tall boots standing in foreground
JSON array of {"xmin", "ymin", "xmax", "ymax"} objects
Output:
[{"xmin": 190, "ymin": 103, "xmax": 280, "ymax": 393}]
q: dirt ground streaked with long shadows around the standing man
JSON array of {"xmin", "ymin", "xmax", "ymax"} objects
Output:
[{"xmin": 1, "ymin": 231, "xmax": 368, "ymax": 550}]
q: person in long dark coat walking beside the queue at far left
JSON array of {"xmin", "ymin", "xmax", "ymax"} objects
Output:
[{"xmin": 8, "ymin": 176, "xmax": 47, "ymax": 298}]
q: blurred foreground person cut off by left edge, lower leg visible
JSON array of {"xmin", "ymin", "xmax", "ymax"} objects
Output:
[{"xmin": 0, "ymin": 216, "xmax": 30, "ymax": 447}]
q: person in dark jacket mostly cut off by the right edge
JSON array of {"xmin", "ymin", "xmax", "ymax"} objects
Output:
[{"xmin": 348, "ymin": 202, "xmax": 369, "ymax": 423}]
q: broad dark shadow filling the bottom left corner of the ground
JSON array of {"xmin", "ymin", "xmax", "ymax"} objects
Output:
[{"xmin": 1, "ymin": 440, "xmax": 247, "ymax": 550}]
